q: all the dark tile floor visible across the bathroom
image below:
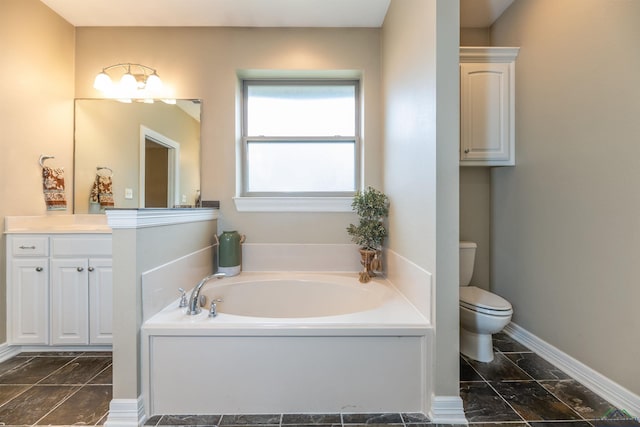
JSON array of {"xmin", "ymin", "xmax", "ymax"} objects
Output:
[{"xmin": 0, "ymin": 334, "xmax": 640, "ymax": 427}]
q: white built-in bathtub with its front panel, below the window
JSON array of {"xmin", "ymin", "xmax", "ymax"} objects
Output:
[{"xmin": 142, "ymin": 273, "xmax": 433, "ymax": 416}]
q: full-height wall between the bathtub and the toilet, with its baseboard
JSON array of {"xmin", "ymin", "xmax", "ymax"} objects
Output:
[{"xmin": 382, "ymin": 0, "xmax": 464, "ymax": 422}]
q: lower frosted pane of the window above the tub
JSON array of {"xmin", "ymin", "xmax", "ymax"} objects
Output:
[{"xmin": 247, "ymin": 142, "xmax": 355, "ymax": 192}]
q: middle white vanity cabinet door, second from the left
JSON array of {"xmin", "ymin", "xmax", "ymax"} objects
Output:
[{"xmin": 51, "ymin": 258, "xmax": 89, "ymax": 345}]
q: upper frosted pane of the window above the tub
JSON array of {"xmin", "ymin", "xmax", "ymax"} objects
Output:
[{"xmin": 247, "ymin": 85, "xmax": 356, "ymax": 137}]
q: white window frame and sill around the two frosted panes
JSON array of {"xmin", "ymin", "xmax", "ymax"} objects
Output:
[{"xmin": 234, "ymin": 78, "xmax": 362, "ymax": 212}]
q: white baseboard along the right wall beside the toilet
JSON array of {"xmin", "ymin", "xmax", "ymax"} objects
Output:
[{"xmin": 504, "ymin": 322, "xmax": 640, "ymax": 417}]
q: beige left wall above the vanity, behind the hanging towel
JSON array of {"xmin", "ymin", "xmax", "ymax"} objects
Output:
[{"xmin": 0, "ymin": 0, "xmax": 75, "ymax": 342}]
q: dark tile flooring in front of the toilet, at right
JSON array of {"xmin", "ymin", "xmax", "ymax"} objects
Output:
[{"xmin": 460, "ymin": 333, "xmax": 640, "ymax": 427}]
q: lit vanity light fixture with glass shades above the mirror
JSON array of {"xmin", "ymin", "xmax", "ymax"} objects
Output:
[{"xmin": 93, "ymin": 62, "xmax": 173, "ymax": 103}]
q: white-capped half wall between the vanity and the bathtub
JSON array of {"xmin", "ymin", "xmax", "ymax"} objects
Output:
[{"xmin": 107, "ymin": 214, "xmax": 217, "ymax": 414}]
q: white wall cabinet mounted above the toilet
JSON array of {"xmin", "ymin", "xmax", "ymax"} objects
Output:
[{"xmin": 460, "ymin": 47, "xmax": 519, "ymax": 166}]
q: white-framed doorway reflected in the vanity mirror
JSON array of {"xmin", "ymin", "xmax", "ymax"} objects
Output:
[{"xmin": 139, "ymin": 126, "xmax": 180, "ymax": 208}]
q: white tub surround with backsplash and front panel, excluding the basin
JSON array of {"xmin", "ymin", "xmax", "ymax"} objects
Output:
[{"xmin": 140, "ymin": 241, "xmax": 433, "ymax": 422}]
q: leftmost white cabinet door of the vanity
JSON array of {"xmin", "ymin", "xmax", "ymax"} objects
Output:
[{"xmin": 8, "ymin": 258, "xmax": 49, "ymax": 344}]
